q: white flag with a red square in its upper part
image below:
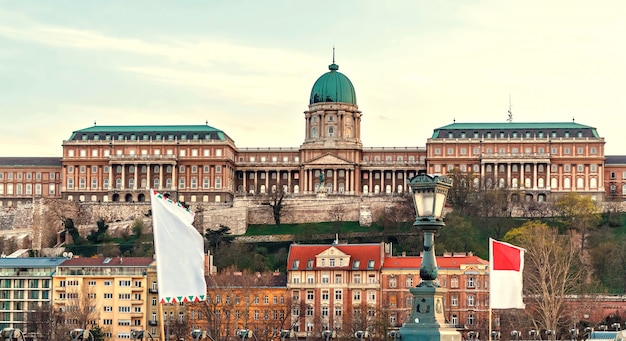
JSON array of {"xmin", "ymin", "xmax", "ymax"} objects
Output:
[{"xmin": 489, "ymin": 238, "xmax": 525, "ymax": 309}]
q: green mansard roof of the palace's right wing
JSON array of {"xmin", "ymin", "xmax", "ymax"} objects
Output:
[{"xmin": 432, "ymin": 122, "xmax": 600, "ymax": 138}]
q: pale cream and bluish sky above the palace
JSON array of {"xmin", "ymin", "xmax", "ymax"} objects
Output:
[{"xmin": 0, "ymin": 0, "xmax": 626, "ymax": 157}]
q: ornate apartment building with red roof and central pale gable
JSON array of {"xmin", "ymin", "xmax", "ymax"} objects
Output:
[{"xmin": 287, "ymin": 243, "xmax": 385, "ymax": 337}]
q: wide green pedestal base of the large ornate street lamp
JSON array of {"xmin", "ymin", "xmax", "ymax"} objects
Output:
[{"xmin": 400, "ymin": 286, "xmax": 461, "ymax": 341}]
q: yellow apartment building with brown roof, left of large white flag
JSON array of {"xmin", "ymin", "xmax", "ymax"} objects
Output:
[{"xmin": 52, "ymin": 257, "xmax": 154, "ymax": 340}]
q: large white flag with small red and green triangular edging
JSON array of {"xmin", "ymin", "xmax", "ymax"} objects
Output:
[{"xmin": 150, "ymin": 189, "xmax": 206, "ymax": 303}]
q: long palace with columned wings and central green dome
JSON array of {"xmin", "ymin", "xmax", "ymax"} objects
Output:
[{"xmin": 0, "ymin": 62, "xmax": 626, "ymax": 207}]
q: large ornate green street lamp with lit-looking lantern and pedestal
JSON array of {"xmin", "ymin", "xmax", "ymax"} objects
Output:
[{"xmin": 400, "ymin": 171, "xmax": 461, "ymax": 341}]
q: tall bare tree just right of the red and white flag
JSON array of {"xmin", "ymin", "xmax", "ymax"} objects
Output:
[{"xmin": 504, "ymin": 221, "xmax": 585, "ymax": 330}]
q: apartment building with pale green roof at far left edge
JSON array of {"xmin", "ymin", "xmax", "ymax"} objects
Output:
[{"xmin": 0, "ymin": 258, "xmax": 67, "ymax": 337}]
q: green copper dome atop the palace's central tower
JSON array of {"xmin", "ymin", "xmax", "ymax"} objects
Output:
[{"xmin": 309, "ymin": 63, "xmax": 356, "ymax": 104}]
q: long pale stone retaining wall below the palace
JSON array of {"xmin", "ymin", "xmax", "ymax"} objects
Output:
[{"xmin": 0, "ymin": 196, "xmax": 405, "ymax": 250}]
